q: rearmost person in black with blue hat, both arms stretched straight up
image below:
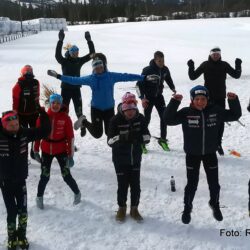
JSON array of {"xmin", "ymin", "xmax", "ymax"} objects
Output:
[{"xmin": 55, "ymin": 30, "xmax": 95, "ymax": 136}]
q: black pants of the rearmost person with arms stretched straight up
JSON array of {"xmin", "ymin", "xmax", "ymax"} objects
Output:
[{"xmin": 61, "ymin": 88, "xmax": 82, "ymax": 118}]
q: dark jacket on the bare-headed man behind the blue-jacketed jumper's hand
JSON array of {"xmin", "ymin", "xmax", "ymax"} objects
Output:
[{"xmin": 136, "ymin": 60, "xmax": 175, "ymax": 100}]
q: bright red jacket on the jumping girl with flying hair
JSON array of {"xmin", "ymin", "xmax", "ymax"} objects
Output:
[{"xmin": 34, "ymin": 109, "xmax": 74, "ymax": 156}]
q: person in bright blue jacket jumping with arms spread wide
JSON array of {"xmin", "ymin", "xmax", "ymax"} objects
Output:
[{"xmin": 48, "ymin": 53, "xmax": 155, "ymax": 138}]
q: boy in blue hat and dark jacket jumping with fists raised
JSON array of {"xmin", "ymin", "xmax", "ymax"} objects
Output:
[{"xmin": 164, "ymin": 85, "xmax": 241, "ymax": 224}]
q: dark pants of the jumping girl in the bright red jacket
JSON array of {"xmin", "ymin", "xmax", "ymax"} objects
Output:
[{"xmin": 37, "ymin": 153, "xmax": 80, "ymax": 197}]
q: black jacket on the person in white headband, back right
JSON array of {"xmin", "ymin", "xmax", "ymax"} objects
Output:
[{"xmin": 188, "ymin": 56, "xmax": 241, "ymax": 100}]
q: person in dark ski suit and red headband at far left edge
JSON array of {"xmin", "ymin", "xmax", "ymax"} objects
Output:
[{"xmin": 0, "ymin": 107, "xmax": 51, "ymax": 250}]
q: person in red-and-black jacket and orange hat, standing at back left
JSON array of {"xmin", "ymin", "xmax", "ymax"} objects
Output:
[{"xmin": 12, "ymin": 65, "xmax": 40, "ymax": 159}]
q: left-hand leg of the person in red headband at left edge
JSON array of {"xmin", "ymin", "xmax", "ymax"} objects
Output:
[{"xmin": 1, "ymin": 181, "xmax": 17, "ymax": 240}]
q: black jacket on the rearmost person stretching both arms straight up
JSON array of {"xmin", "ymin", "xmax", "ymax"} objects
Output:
[{"xmin": 55, "ymin": 41, "xmax": 95, "ymax": 89}]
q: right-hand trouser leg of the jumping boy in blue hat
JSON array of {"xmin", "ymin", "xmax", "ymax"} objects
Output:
[{"xmin": 203, "ymin": 153, "xmax": 220, "ymax": 205}]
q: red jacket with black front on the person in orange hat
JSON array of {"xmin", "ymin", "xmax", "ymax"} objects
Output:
[{"xmin": 12, "ymin": 77, "xmax": 40, "ymax": 115}]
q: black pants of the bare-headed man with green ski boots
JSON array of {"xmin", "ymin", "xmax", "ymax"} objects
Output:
[{"xmin": 144, "ymin": 95, "xmax": 167, "ymax": 139}]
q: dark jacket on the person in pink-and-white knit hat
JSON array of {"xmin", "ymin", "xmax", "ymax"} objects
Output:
[{"xmin": 108, "ymin": 106, "xmax": 150, "ymax": 165}]
